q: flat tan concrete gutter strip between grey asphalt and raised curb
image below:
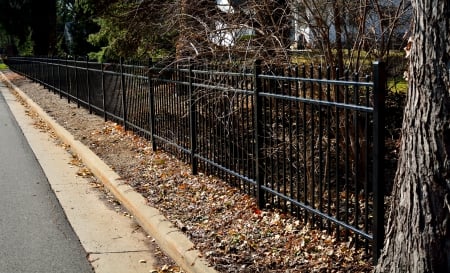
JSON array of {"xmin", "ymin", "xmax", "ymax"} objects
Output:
[{"xmin": 0, "ymin": 75, "xmax": 162, "ymax": 273}]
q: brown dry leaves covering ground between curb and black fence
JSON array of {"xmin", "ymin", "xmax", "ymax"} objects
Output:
[{"xmin": 10, "ymin": 72, "xmax": 373, "ymax": 273}]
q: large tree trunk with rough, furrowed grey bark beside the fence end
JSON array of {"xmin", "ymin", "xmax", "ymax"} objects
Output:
[{"xmin": 376, "ymin": 0, "xmax": 450, "ymax": 272}]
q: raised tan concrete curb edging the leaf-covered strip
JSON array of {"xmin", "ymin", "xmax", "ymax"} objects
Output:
[{"xmin": 0, "ymin": 71, "xmax": 218, "ymax": 273}]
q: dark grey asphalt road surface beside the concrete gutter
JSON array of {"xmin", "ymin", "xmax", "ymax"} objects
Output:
[{"xmin": 0, "ymin": 83, "xmax": 93, "ymax": 273}]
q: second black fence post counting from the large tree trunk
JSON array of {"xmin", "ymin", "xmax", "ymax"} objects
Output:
[{"xmin": 253, "ymin": 60, "xmax": 266, "ymax": 208}]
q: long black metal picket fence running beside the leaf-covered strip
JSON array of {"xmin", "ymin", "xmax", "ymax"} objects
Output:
[{"xmin": 7, "ymin": 55, "xmax": 386, "ymax": 259}]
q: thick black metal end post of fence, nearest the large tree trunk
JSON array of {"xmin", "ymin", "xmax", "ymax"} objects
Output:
[{"xmin": 373, "ymin": 62, "xmax": 386, "ymax": 264}]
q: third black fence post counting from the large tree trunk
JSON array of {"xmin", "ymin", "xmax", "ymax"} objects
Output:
[{"xmin": 188, "ymin": 59, "xmax": 198, "ymax": 175}]
